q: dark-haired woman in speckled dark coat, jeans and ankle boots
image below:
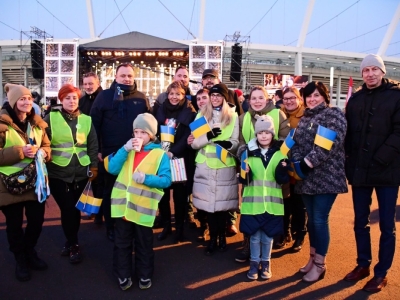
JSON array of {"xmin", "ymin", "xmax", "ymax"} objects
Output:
[{"xmin": 292, "ymin": 81, "xmax": 347, "ymax": 282}]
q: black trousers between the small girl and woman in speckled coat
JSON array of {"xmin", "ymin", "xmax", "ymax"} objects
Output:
[{"xmin": 283, "ymin": 184, "xmax": 307, "ymax": 239}]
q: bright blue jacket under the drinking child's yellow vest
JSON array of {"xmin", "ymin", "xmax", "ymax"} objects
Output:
[{"xmin": 108, "ymin": 142, "xmax": 172, "ymax": 189}]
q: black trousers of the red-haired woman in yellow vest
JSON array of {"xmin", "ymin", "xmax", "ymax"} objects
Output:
[{"xmin": 49, "ymin": 178, "xmax": 87, "ymax": 246}]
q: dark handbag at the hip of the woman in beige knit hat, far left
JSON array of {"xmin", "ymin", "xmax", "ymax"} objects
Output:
[{"xmin": 1, "ymin": 160, "xmax": 37, "ymax": 195}]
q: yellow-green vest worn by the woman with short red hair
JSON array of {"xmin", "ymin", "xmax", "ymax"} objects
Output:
[{"xmin": 50, "ymin": 112, "xmax": 92, "ymax": 167}]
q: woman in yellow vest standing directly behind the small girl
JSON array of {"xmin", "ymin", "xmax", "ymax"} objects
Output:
[{"xmin": 235, "ymin": 86, "xmax": 290, "ymax": 262}]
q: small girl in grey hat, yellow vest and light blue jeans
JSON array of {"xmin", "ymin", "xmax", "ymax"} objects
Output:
[{"xmin": 240, "ymin": 115, "xmax": 289, "ymax": 280}]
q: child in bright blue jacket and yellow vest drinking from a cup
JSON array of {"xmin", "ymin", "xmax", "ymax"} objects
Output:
[{"xmin": 104, "ymin": 113, "xmax": 171, "ymax": 290}]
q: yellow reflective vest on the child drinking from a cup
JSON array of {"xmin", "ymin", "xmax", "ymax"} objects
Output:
[{"xmin": 111, "ymin": 149, "xmax": 165, "ymax": 227}]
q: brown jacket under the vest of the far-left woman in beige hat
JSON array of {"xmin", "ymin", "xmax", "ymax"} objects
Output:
[{"xmin": 0, "ymin": 107, "xmax": 51, "ymax": 208}]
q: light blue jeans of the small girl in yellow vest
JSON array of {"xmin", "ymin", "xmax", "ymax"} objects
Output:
[{"xmin": 250, "ymin": 229, "xmax": 274, "ymax": 263}]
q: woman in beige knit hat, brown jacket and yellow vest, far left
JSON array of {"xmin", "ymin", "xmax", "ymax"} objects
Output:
[{"xmin": 0, "ymin": 83, "xmax": 51, "ymax": 281}]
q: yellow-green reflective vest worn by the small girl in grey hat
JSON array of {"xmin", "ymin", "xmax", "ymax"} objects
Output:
[{"xmin": 240, "ymin": 151, "xmax": 287, "ymax": 215}]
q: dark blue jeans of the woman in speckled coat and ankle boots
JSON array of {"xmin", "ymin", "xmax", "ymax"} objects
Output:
[{"xmin": 301, "ymin": 194, "xmax": 337, "ymax": 256}]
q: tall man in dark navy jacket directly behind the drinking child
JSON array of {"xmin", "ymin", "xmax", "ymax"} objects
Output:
[{"xmin": 90, "ymin": 63, "xmax": 150, "ymax": 241}]
